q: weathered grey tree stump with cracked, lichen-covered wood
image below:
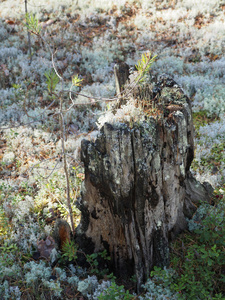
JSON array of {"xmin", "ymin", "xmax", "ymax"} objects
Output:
[{"xmin": 77, "ymin": 70, "xmax": 213, "ymax": 290}]
